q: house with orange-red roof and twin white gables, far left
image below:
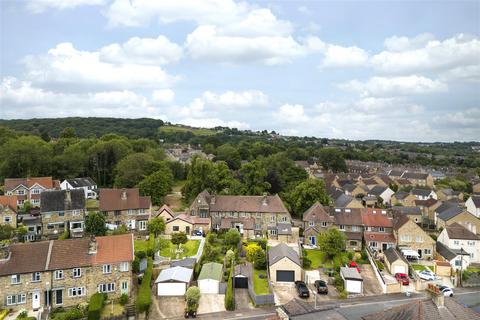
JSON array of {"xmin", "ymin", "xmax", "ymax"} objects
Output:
[{"xmin": 5, "ymin": 177, "xmax": 60, "ymax": 207}]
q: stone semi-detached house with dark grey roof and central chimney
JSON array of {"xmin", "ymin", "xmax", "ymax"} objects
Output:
[{"xmin": 40, "ymin": 189, "xmax": 86, "ymax": 238}]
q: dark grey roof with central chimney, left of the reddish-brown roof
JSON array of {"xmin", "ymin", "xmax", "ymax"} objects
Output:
[{"xmin": 40, "ymin": 189, "xmax": 86, "ymax": 213}]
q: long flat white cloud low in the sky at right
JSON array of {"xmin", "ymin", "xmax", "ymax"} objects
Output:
[{"xmin": 340, "ymin": 75, "xmax": 447, "ymax": 97}]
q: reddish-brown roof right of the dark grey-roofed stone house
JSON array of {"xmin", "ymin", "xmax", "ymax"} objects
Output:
[{"xmin": 100, "ymin": 188, "xmax": 151, "ymax": 211}]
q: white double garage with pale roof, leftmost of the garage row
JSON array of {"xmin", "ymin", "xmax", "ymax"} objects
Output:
[{"xmin": 155, "ymin": 267, "xmax": 193, "ymax": 296}]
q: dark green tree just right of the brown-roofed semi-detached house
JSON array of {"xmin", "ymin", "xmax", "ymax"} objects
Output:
[{"xmin": 138, "ymin": 162, "xmax": 173, "ymax": 206}]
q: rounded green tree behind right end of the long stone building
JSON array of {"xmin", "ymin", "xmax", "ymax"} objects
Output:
[{"xmin": 287, "ymin": 179, "xmax": 330, "ymax": 217}]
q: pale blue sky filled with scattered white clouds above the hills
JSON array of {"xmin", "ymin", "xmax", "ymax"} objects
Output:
[{"xmin": 0, "ymin": 0, "xmax": 480, "ymax": 142}]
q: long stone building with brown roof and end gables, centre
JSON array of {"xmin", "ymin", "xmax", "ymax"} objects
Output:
[{"xmin": 188, "ymin": 190, "xmax": 292, "ymax": 242}]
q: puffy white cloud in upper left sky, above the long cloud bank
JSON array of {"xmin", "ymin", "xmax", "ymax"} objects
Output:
[{"xmin": 100, "ymin": 36, "xmax": 183, "ymax": 65}]
